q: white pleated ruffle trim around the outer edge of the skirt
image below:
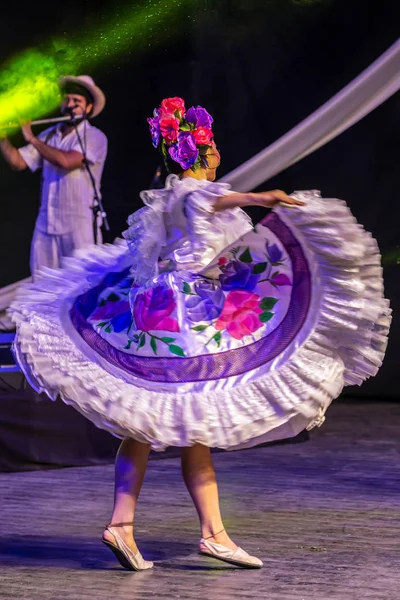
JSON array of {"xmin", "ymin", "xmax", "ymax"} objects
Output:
[{"xmin": 11, "ymin": 192, "xmax": 390, "ymax": 450}]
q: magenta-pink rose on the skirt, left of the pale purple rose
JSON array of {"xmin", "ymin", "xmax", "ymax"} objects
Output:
[{"xmin": 133, "ymin": 285, "xmax": 179, "ymax": 332}]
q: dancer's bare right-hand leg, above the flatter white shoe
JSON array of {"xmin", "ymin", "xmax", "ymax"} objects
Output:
[{"xmin": 182, "ymin": 444, "xmax": 237, "ymax": 550}]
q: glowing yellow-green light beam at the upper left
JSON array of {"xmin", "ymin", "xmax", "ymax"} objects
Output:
[{"xmin": 0, "ymin": 0, "xmax": 194, "ymax": 135}]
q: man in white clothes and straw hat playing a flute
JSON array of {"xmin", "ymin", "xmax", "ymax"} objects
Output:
[{"xmin": 0, "ymin": 75, "xmax": 107, "ymax": 276}]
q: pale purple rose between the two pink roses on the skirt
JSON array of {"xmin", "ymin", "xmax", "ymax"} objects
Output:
[{"xmin": 186, "ymin": 279, "xmax": 225, "ymax": 323}]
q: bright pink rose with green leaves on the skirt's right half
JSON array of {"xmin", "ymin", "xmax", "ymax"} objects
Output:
[{"xmin": 215, "ymin": 290, "xmax": 264, "ymax": 340}]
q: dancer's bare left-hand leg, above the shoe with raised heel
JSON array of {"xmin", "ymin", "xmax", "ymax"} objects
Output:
[{"xmin": 103, "ymin": 439, "xmax": 150, "ymax": 553}]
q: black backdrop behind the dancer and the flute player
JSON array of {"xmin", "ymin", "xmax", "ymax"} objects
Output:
[{"xmin": 0, "ymin": 0, "xmax": 400, "ymax": 398}]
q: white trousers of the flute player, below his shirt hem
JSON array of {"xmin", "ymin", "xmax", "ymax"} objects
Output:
[{"xmin": 30, "ymin": 227, "xmax": 103, "ymax": 277}]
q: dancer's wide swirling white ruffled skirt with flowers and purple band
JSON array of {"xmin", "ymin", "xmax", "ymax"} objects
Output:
[{"xmin": 10, "ymin": 191, "xmax": 391, "ymax": 450}]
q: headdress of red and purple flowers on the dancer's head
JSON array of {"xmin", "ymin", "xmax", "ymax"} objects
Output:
[{"xmin": 147, "ymin": 97, "xmax": 214, "ymax": 171}]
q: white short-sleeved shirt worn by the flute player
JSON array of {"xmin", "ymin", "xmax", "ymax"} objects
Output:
[{"xmin": 19, "ymin": 120, "xmax": 107, "ymax": 235}]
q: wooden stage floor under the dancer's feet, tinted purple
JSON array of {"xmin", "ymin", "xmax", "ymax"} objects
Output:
[{"xmin": 0, "ymin": 400, "xmax": 400, "ymax": 600}]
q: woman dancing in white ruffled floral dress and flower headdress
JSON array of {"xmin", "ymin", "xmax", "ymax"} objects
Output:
[{"xmin": 12, "ymin": 98, "xmax": 390, "ymax": 570}]
